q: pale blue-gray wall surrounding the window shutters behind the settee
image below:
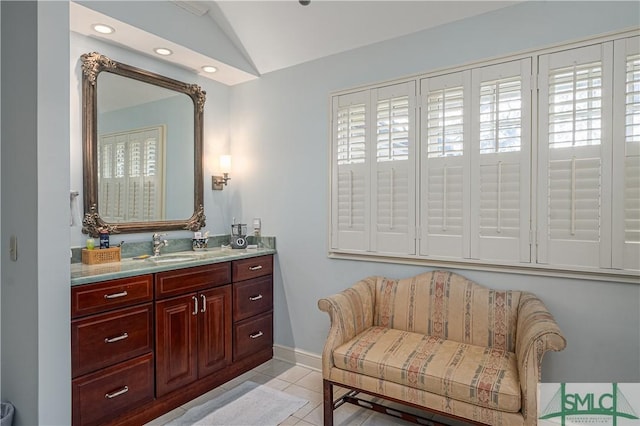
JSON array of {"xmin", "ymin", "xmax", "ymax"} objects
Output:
[{"xmin": 225, "ymin": 2, "xmax": 640, "ymax": 382}]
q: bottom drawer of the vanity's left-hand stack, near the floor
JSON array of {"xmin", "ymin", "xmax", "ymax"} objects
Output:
[{"xmin": 71, "ymin": 353, "xmax": 153, "ymax": 426}]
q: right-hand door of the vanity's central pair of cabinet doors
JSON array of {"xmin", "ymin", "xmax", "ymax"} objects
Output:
[{"xmin": 198, "ymin": 285, "xmax": 232, "ymax": 377}]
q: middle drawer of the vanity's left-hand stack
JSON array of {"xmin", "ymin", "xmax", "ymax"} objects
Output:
[{"xmin": 71, "ymin": 303, "xmax": 153, "ymax": 377}]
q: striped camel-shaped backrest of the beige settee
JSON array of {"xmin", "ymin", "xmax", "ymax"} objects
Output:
[{"xmin": 373, "ymin": 271, "xmax": 520, "ymax": 352}]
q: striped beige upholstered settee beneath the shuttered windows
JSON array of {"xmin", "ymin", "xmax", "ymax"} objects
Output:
[{"xmin": 318, "ymin": 271, "xmax": 566, "ymax": 426}]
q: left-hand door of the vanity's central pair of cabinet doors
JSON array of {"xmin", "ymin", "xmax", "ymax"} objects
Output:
[{"xmin": 156, "ymin": 293, "xmax": 199, "ymax": 396}]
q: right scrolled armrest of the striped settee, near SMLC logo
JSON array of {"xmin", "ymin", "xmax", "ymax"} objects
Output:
[{"xmin": 516, "ymin": 292, "xmax": 567, "ymax": 425}]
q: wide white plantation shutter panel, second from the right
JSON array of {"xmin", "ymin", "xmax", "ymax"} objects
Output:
[{"xmin": 538, "ymin": 43, "xmax": 613, "ymax": 268}]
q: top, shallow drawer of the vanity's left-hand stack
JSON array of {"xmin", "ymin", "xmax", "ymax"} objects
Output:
[{"xmin": 71, "ymin": 275, "xmax": 153, "ymax": 318}]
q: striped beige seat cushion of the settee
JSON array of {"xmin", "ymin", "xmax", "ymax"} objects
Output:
[{"xmin": 333, "ymin": 326, "xmax": 521, "ymax": 412}]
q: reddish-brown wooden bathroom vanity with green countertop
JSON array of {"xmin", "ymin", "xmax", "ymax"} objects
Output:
[{"xmin": 71, "ymin": 249, "xmax": 275, "ymax": 426}]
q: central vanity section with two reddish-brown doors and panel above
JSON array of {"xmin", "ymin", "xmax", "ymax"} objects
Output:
[{"xmin": 156, "ymin": 263, "xmax": 232, "ymax": 396}]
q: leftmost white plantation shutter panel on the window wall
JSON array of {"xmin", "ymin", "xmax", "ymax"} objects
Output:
[{"xmin": 331, "ymin": 91, "xmax": 371, "ymax": 251}]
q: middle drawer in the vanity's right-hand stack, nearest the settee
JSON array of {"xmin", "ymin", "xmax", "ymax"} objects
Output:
[{"xmin": 233, "ymin": 275, "xmax": 273, "ymax": 321}]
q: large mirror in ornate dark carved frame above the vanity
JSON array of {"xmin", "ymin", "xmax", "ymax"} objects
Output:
[{"xmin": 81, "ymin": 52, "xmax": 206, "ymax": 237}]
